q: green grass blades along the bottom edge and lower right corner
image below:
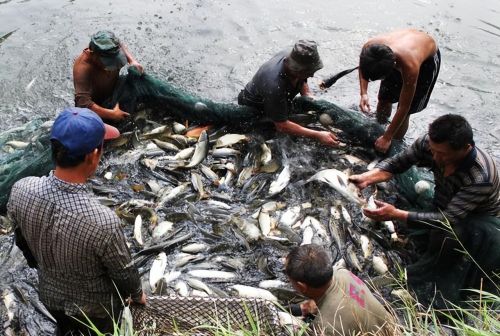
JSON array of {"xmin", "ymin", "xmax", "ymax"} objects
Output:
[{"xmin": 76, "ymin": 215, "xmax": 500, "ymax": 336}]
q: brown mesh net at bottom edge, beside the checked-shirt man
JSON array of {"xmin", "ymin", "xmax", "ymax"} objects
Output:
[{"xmin": 131, "ymin": 296, "xmax": 284, "ymax": 335}]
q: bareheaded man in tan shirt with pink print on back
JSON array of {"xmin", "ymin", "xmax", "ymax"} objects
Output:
[{"xmin": 285, "ymin": 244, "xmax": 396, "ymax": 336}]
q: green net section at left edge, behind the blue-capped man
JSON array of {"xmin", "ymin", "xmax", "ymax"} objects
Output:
[{"xmin": 0, "ymin": 119, "xmax": 53, "ymax": 212}]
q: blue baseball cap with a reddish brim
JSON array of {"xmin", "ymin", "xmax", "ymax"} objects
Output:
[{"xmin": 50, "ymin": 107, "xmax": 120, "ymax": 156}]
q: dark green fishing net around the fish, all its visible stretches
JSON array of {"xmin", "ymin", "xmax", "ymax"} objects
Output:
[{"xmin": 0, "ymin": 67, "xmax": 430, "ymax": 212}]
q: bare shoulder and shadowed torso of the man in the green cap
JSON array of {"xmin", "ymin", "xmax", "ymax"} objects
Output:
[{"xmin": 73, "ymin": 48, "xmax": 120, "ymax": 109}]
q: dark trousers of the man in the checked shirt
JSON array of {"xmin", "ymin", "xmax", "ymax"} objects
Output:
[{"xmin": 49, "ymin": 310, "xmax": 118, "ymax": 336}]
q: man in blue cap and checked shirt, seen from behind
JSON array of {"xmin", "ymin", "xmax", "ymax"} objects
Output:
[{"xmin": 7, "ymin": 107, "xmax": 146, "ymax": 335}]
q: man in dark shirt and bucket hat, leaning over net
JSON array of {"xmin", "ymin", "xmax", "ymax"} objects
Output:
[{"xmin": 238, "ymin": 40, "xmax": 339, "ymax": 146}]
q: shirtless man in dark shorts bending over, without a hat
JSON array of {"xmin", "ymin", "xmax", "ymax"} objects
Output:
[{"xmin": 359, "ymin": 29, "xmax": 441, "ymax": 153}]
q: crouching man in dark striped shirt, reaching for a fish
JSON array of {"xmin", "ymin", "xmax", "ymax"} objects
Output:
[{"xmin": 350, "ymin": 114, "xmax": 500, "ymax": 301}]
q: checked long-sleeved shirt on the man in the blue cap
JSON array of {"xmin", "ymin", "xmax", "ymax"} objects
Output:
[{"xmin": 7, "ymin": 172, "xmax": 142, "ymax": 317}]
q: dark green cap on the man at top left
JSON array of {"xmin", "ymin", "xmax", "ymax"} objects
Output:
[{"xmin": 89, "ymin": 30, "xmax": 127, "ymax": 70}]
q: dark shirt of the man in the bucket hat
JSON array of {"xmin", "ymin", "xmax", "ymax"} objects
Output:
[{"xmin": 243, "ymin": 50, "xmax": 306, "ymax": 122}]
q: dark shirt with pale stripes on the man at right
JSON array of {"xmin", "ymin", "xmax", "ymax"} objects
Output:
[{"xmin": 376, "ymin": 135, "xmax": 500, "ymax": 224}]
